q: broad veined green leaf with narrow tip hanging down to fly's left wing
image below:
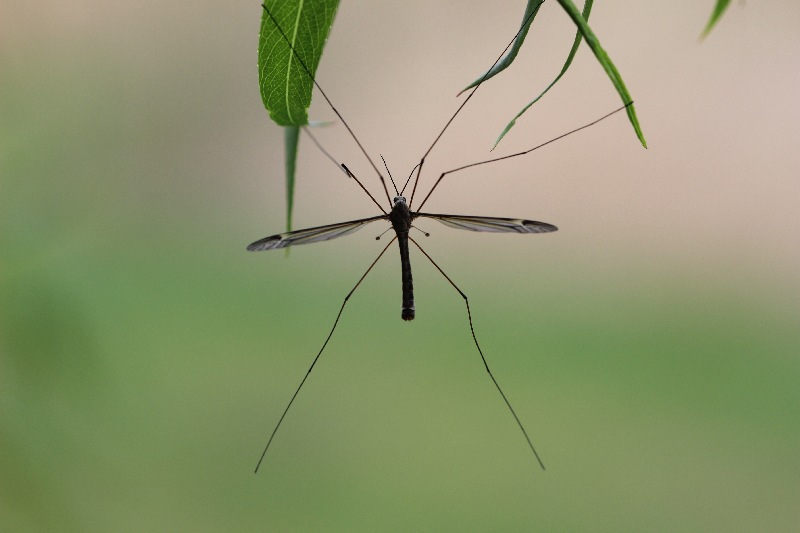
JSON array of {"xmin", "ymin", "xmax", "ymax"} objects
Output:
[{"xmin": 258, "ymin": 0, "xmax": 339, "ymax": 231}]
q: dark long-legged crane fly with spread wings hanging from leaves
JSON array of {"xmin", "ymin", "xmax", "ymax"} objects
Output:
[{"xmin": 252, "ymin": 5, "xmax": 630, "ymax": 472}]
